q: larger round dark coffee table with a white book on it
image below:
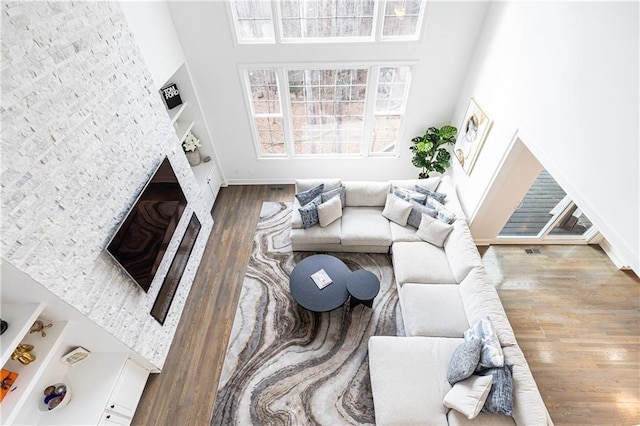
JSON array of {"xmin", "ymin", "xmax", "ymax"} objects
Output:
[{"xmin": 289, "ymin": 254, "xmax": 351, "ymax": 312}]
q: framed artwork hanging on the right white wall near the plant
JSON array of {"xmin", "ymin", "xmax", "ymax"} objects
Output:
[{"xmin": 454, "ymin": 98, "xmax": 493, "ymax": 175}]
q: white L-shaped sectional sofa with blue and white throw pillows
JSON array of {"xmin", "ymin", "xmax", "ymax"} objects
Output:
[{"xmin": 290, "ymin": 176, "xmax": 552, "ymax": 426}]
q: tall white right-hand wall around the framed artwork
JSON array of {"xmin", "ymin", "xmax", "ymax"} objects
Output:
[{"xmin": 452, "ymin": 2, "xmax": 640, "ymax": 273}]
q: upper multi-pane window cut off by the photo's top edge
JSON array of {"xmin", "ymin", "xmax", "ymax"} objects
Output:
[{"xmin": 231, "ymin": 0, "xmax": 426, "ymax": 43}]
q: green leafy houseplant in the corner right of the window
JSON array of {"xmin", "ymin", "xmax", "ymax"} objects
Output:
[{"xmin": 409, "ymin": 125, "xmax": 458, "ymax": 179}]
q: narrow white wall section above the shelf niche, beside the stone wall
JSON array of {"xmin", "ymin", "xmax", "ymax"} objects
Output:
[{"xmin": 119, "ymin": 0, "xmax": 184, "ymax": 89}]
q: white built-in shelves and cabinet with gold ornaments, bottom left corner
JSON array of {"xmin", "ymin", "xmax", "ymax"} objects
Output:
[{"xmin": 0, "ymin": 261, "xmax": 152, "ymax": 425}]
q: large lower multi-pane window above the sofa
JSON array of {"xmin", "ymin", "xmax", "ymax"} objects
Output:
[{"xmin": 244, "ymin": 65, "xmax": 411, "ymax": 157}]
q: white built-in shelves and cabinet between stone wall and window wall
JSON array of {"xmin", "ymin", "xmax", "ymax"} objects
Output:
[{"xmin": 160, "ymin": 64, "xmax": 224, "ymax": 210}]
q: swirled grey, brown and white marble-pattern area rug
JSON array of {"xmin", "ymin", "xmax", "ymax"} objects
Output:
[{"xmin": 211, "ymin": 202, "xmax": 403, "ymax": 425}]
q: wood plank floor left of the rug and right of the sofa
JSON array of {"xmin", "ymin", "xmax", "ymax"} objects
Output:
[{"xmin": 133, "ymin": 185, "xmax": 640, "ymax": 425}]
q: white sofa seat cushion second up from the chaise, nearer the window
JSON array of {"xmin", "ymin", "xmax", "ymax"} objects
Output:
[{"xmin": 393, "ymin": 241, "xmax": 456, "ymax": 285}]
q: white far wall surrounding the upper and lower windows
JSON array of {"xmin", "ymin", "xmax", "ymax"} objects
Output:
[{"xmin": 169, "ymin": 1, "xmax": 487, "ymax": 184}]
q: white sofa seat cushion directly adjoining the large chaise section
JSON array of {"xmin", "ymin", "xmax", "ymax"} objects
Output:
[{"xmin": 400, "ymin": 283, "xmax": 469, "ymax": 338}]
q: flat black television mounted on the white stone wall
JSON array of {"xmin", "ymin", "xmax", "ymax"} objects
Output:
[{"xmin": 106, "ymin": 157, "xmax": 187, "ymax": 291}]
